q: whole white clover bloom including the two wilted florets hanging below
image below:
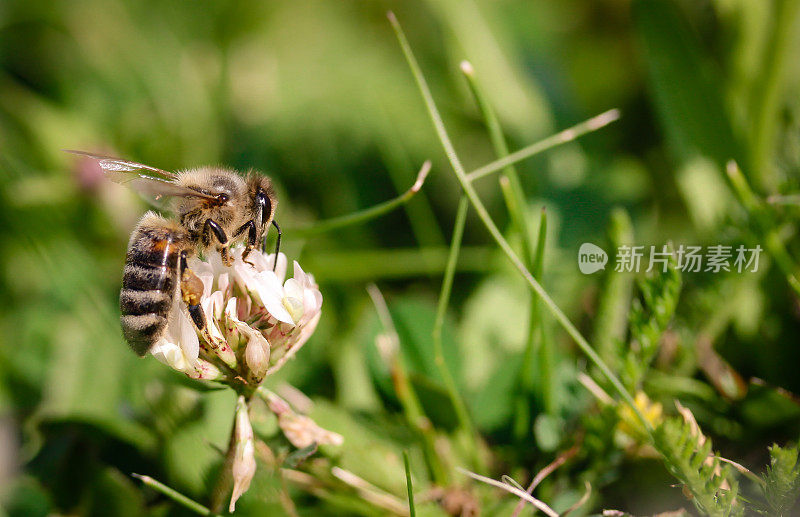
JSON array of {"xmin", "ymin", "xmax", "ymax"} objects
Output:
[{"xmin": 142, "ymin": 248, "xmax": 343, "ymax": 506}]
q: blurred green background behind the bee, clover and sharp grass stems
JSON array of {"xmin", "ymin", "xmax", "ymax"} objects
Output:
[{"xmin": 0, "ymin": 0, "xmax": 800, "ymax": 515}]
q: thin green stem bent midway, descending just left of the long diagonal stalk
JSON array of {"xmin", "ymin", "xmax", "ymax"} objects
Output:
[{"xmin": 433, "ymin": 195, "xmax": 483, "ymax": 467}]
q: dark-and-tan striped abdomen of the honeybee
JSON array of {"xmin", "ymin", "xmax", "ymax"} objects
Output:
[{"xmin": 119, "ymin": 214, "xmax": 185, "ymax": 356}]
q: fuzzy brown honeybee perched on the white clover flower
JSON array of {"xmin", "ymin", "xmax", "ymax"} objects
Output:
[{"xmin": 67, "ymin": 150, "xmax": 281, "ymax": 356}]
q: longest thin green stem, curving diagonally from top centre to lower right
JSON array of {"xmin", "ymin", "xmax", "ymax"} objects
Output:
[{"xmin": 389, "ymin": 12, "xmax": 653, "ymax": 434}]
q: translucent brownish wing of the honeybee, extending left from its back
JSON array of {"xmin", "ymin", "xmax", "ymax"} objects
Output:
[{"xmin": 65, "ymin": 149, "xmax": 215, "ymax": 205}]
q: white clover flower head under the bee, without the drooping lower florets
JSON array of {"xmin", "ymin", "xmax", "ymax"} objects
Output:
[{"xmin": 151, "ymin": 248, "xmax": 322, "ymax": 385}]
